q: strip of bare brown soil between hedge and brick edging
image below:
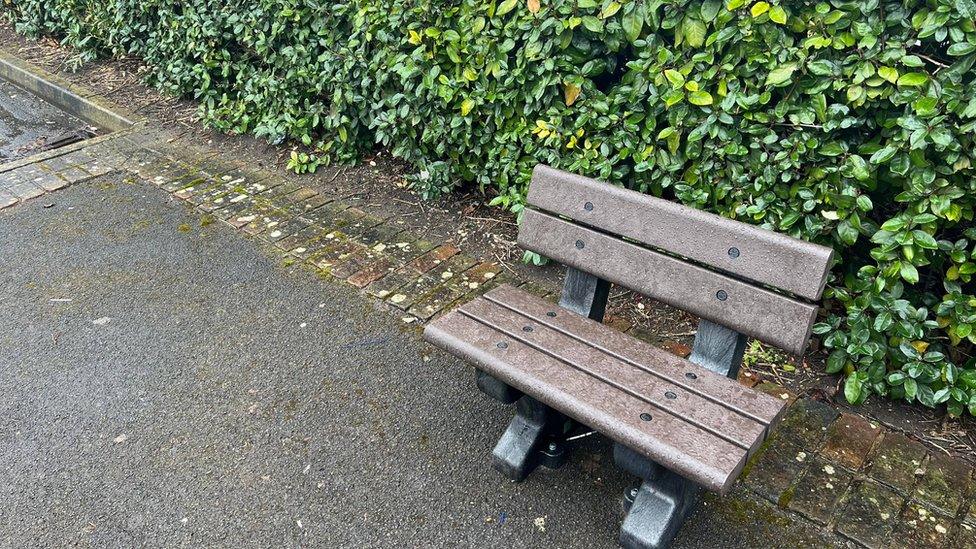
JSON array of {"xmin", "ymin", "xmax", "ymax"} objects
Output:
[{"xmin": 0, "ymin": 22, "xmax": 976, "ymax": 463}]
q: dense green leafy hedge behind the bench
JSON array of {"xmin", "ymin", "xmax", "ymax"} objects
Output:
[{"xmin": 7, "ymin": 0, "xmax": 976, "ymax": 415}]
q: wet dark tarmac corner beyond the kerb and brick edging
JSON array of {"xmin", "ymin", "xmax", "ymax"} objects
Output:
[{"xmin": 0, "ymin": 80, "xmax": 96, "ymax": 164}]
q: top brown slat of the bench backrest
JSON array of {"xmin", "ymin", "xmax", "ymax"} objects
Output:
[{"xmin": 525, "ymin": 165, "xmax": 833, "ymax": 300}]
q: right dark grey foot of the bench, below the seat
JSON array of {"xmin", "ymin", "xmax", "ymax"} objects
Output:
[{"xmin": 613, "ymin": 444, "xmax": 701, "ymax": 549}]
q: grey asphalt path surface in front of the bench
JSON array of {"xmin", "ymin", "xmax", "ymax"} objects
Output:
[{"xmin": 0, "ymin": 176, "xmax": 848, "ymax": 548}]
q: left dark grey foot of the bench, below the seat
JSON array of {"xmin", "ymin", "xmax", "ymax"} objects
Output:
[{"xmin": 492, "ymin": 395, "xmax": 568, "ymax": 482}]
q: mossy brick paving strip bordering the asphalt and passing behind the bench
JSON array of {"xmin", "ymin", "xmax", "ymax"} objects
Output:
[{"xmin": 0, "ymin": 103, "xmax": 976, "ymax": 548}]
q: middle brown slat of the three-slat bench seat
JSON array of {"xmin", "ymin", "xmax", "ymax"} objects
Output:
[{"xmin": 460, "ymin": 298, "xmax": 766, "ymax": 453}]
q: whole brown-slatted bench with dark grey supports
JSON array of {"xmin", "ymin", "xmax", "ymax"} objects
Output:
[{"xmin": 424, "ymin": 165, "xmax": 832, "ymax": 547}]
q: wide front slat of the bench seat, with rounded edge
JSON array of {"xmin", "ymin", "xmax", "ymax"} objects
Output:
[{"xmin": 424, "ymin": 311, "xmax": 747, "ymax": 493}]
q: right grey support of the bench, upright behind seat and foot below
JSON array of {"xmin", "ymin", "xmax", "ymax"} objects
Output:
[{"xmin": 613, "ymin": 319, "xmax": 747, "ymax": 549}]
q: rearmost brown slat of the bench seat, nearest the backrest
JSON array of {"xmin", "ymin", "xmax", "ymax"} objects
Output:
[{"xmin": 484, "ymin": 284, "xmax": 784, "ymax": 426}]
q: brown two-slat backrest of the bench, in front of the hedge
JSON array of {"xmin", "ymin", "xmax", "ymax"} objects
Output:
[{"xmin": 518, "ymin": 165, "xmax": 833, "ymax": 354}]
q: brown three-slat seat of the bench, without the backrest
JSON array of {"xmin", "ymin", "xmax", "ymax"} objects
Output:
[{"xmin": 424, "ymin": 285, "xmax": 785, "ymax": 494}]
